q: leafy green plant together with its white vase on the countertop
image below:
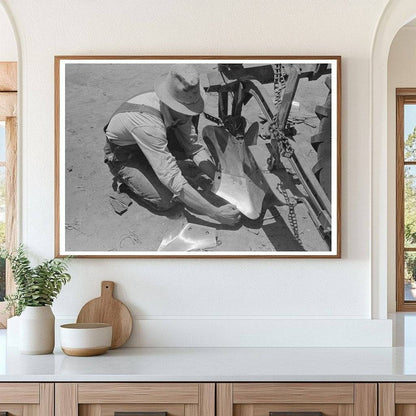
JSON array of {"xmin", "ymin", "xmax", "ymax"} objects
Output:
[{"xmin": 0, "ymin": 246, "xmax": 71, "ymax": 354}]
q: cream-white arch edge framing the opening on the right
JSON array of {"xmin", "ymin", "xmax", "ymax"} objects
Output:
[{"xmin": 370, "ymin": 0, "xmax": 416, "ymax": 319}]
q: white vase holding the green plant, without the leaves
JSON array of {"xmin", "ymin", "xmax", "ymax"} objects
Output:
[{"xmin": 19, "ymin": 306, "xmax": 55, "ymax": 355}]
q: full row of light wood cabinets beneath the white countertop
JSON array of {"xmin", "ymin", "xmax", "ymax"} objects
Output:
[{"xmin": 0, "ymin": 383, "xmax": 384, "ymax": 416}]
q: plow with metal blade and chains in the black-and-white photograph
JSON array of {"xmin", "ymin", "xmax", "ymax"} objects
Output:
[{"xmin": 202, "ymin": 63, "xmax": 333, "ymax": 250}]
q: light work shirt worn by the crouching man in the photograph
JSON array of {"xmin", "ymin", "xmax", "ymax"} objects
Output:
[{"xmin": 106, "ymin": 92, "xmax": 210, "ymax": 195}]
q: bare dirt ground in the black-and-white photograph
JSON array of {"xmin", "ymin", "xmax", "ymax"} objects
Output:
[{"xmin": 65, "ymin": 64, "xmax": 328, "ymax": 252}]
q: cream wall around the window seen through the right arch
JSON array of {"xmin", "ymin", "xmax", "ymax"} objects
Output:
[{"xmin": 387, "ymin": 25, "xmax": 416, "ymax": 312}]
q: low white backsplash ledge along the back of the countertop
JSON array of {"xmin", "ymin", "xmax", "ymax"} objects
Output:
[{"xmin": 57, "ymin": 317, "xmax": 392, "ymax": 348}]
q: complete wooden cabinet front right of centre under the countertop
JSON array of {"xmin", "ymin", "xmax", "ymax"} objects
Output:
[{"xmin": 217, "ymin": 383, "xmax": 377, "ymax": 416}]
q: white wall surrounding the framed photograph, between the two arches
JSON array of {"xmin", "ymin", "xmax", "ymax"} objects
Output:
[{"xmin": 0, "ymin": 0, "xmax": 391, "ymax": 346}]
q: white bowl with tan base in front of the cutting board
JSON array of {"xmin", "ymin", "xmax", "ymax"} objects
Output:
[{"xmin": 60, "ymin": 323, "xmax": 113, "ymax": 357}]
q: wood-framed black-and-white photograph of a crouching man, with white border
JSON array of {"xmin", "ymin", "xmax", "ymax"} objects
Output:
[{"xmin": 55, "ymin": 56, "xmax": 341, "ymax": 258}]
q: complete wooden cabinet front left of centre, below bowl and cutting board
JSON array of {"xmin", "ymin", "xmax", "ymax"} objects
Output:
[{"xmin": 55, "ymin": 383, "xmax": 215, "ymax": 416}]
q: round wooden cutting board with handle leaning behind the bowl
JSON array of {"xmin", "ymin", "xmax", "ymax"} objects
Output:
[{"xmin": 77, "ymin": 281, "xmax": 133, "ymax": 349}]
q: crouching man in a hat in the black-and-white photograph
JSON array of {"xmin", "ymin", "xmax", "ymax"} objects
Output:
[{"xmin": 104, "ymin": 65, "xmax": 240, "ymax": 226}]
